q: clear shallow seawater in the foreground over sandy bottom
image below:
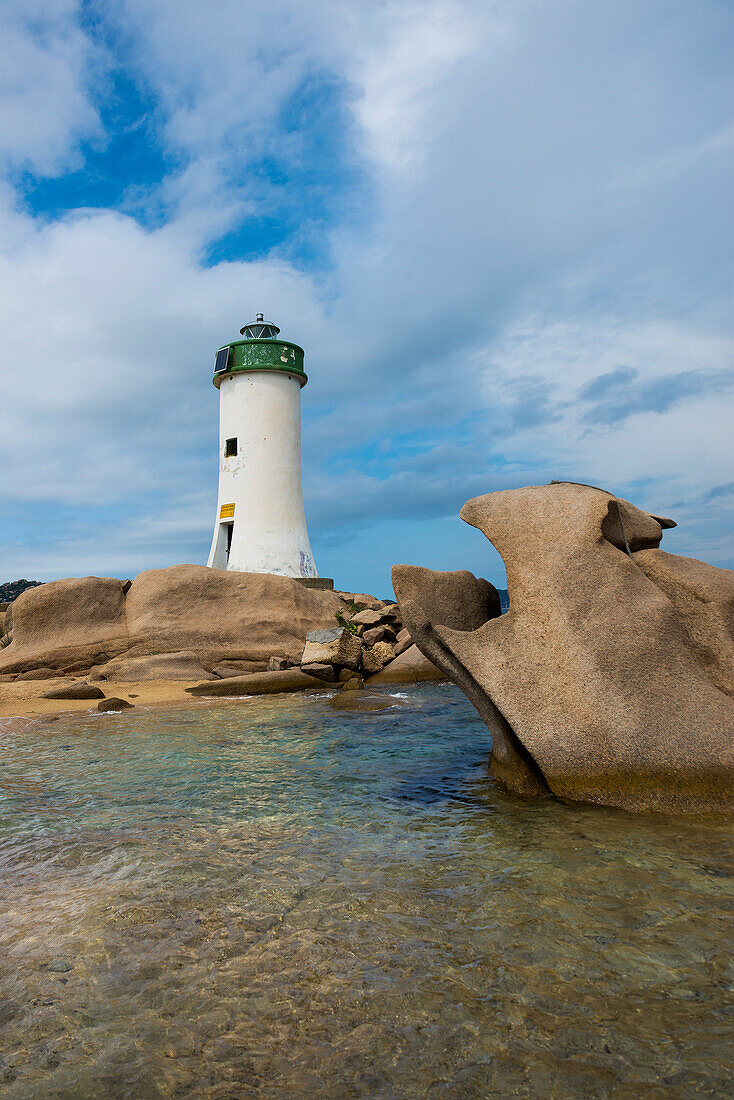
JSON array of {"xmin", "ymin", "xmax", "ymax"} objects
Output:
[{"xmin": 0, "ymin": 685, "xmax": 732, "ymax": 1100}]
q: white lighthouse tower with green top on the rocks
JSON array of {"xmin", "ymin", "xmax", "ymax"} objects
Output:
[{"xmin": 207, "ymin": 314, "xmax": 321, "ymax": 586}]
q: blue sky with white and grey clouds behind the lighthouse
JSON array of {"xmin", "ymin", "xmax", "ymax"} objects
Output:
[{"xmin": 0, "ymin": 0, "xmax": 734, "ymax": 594}]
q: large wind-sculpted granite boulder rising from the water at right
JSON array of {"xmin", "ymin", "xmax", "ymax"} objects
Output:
[{"xmin": 393, "ymin": 483, "xmax": 734, "ymax": 813}]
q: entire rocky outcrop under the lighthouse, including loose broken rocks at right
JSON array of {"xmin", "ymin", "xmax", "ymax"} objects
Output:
[{"xmin": 0, "ymin": 565, "xmax": 442, "ymax": 694}]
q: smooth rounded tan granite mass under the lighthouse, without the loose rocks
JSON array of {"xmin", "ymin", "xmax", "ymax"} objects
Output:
[{"xmin": 0, "ymin": 565, "xmax": 343, "ymax": 679}]
